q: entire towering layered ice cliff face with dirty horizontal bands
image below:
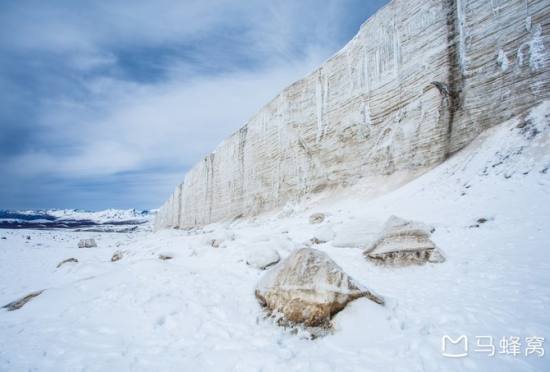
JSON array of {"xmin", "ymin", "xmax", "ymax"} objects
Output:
[{"xmin": 155, "ymin": 0, "xmax": 550, "ymax": 229}]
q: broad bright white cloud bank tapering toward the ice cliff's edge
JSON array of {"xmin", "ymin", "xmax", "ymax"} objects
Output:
[{"xmin": 5, "ymin": 49, "xmax": 328, "ymax": 177}]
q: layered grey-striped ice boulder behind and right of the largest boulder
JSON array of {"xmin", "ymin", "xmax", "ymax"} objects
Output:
[{"xmin": 364, "ymin": 216, "xmax": 445, "ymax": 266}]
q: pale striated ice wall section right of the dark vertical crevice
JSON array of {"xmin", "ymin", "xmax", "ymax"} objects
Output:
[{"xmin": 450, "ymin": 0, "xmax": 550, "ymax": 151}]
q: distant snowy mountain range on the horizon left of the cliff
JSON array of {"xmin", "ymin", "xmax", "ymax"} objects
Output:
[{"xmin": 0, "ymin": 209, "xmax": 156, "ymax": 232}]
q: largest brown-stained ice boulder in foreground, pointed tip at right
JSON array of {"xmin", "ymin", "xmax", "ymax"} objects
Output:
[{"xmin": 256, "ymin": 248, "xmax": 384, "ymax": 327}]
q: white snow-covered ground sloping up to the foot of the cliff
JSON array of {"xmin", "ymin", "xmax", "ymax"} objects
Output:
[{"xmin": 0, "ymin": 104, "xmax": 550, "ymax": 372}]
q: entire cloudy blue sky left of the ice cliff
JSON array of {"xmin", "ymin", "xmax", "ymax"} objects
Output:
[{"xmin": 0, "ymin": 0, "xmax": 386, "ymax": 210}]
